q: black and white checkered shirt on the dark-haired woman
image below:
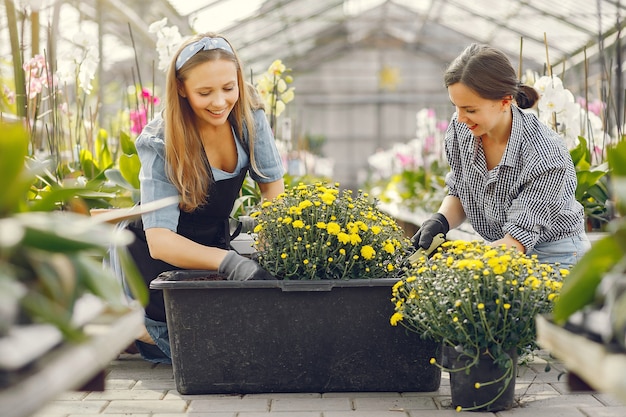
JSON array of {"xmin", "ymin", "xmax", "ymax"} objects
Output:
[{"xmin": 445, "ymin": 106, "xmax": 584, "ymax": 251}]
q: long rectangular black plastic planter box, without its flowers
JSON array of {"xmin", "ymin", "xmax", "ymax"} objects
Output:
[{"xmin": 150, "ymin": 271, "xmax": 441, "ymax": 394}]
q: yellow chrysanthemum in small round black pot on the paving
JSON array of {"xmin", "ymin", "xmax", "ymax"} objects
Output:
[{"xmin": 391, "ymin": 240, "xmax": 569, "ymax": 411}]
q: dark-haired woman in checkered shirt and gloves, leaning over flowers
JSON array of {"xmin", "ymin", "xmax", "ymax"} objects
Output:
[{"xmin": 412, "ymin": 44, "xmax": 590, "ymax": 267}]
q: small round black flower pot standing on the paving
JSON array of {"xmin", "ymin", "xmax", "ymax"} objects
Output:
[{"xmin": 443, "ymin": 346, "xmax": 517, "ymax": 412}]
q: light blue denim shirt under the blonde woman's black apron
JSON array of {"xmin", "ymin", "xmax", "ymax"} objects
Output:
[{"xmin": 135, "ymin": 110, "xmax": 284, "ymax": 231}]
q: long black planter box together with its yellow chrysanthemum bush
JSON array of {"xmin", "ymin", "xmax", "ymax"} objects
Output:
[{"xmin": 152, "ymin": 183, "xmax": 441, "ymax": 394}]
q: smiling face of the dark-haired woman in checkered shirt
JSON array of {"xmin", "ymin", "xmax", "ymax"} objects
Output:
[{"xmin": 448, "ymin": 83, "xmax": 511, "ymax": 137}]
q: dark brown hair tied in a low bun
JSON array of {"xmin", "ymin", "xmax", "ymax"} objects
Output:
[{"xmin": 443, "ymin": 43, "xmax": 539, "ymax": 109}]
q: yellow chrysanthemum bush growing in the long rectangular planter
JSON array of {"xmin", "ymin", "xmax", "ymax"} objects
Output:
[{"xmin": 252, "ymin": 183, "xmax": 411, "ymax": 279}]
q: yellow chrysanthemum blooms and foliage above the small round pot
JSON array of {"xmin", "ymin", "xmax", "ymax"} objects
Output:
[{"xmin": 390, "ymin": 241, "xmax": 569, "ymax": 352}]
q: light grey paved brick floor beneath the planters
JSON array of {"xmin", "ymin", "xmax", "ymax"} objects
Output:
[{"xmin": 30, "ymin": 348, "xmax": 626, "ymax": 417}]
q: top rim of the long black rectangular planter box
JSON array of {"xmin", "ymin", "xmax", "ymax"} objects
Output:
[{"xmin": 150, "ymin": 270, "xmax": 400, "ymax": 292}]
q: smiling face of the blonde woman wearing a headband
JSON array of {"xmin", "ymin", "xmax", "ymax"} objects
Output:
[{"xmin": 179, "ymin": 59, "xmax": 239, "ymax": 126}]
